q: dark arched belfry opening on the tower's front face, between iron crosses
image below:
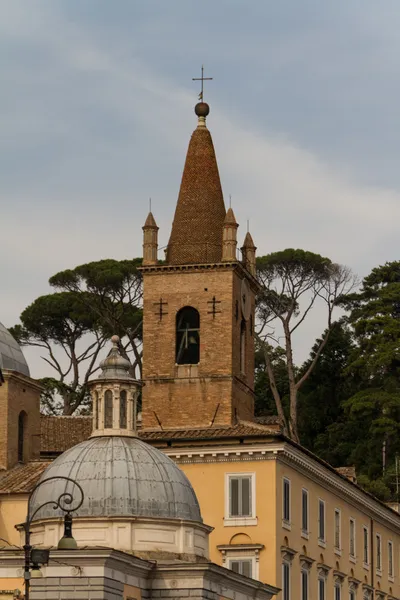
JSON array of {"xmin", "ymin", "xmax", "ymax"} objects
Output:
[{"xmin": 176, "ymin": 306, "xmax": 200, "ymax": 365}]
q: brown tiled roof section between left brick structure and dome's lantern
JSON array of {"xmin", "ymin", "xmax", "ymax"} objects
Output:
[{"xmin": 40, "ymin": 415, "xmax": 92, "ymax": 455}]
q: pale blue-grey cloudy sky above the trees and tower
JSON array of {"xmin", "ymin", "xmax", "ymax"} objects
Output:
[{"xmin": 0, "ymin": 0, "xmax": 400, "ymax": 377}]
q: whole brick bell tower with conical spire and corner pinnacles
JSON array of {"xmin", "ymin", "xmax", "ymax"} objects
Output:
[{"xmin": 142, "ymin": 102, "xmax": 258, "ymax": 429}]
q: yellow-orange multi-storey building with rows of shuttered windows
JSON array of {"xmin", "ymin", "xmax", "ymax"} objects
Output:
[{"xmin": 146, "ymin": 433, "xmax": 400, "ymax": 600}]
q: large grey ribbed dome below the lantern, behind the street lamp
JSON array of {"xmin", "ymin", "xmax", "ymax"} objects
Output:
[{"xmin": 30, "ymin": 436, "xmax": 202, "ymax": 523}]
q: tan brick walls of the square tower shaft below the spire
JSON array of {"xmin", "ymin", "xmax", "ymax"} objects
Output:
[{"xmin": 142, "ymin": 265, "xmax": 254, "ymax": 428}]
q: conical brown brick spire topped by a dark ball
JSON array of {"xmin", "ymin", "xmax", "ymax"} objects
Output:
[{"xmin": 167, "ymin": 102, "xmax": 226, "ymax": 265}]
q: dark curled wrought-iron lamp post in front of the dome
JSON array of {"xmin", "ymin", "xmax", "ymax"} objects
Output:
[{"xmin": 23, "ymin": 475, "xmax": 84, "ymax": 600}]
